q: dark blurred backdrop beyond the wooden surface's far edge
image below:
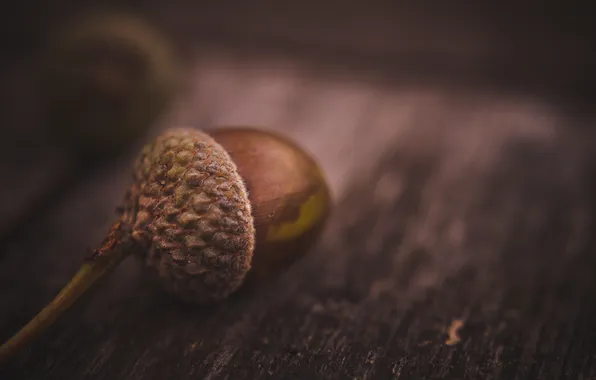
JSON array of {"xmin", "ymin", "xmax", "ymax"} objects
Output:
[{"xmin": 3, "ymin": 0, "xmax": 596, "ymax": 99}]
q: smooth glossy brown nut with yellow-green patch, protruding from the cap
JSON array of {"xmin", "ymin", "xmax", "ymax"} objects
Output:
[{"xmin": 207, "ymin": 127, "xmax": 331, "ymax": 281}]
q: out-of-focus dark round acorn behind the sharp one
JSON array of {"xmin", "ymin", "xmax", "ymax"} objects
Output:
[{"xmin": 39, "ymin": 12, "xmax": 181, "ymax": 157}]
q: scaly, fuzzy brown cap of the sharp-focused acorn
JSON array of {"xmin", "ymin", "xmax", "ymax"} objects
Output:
[{"xmin": 125, "ymin": 129, "xmax": 255, "ymax": 303}]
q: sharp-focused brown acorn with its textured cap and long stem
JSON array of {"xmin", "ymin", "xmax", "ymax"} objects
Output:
[{"xmin": 0, "ymin": 127, "xmax": 331, "ymax": 360}]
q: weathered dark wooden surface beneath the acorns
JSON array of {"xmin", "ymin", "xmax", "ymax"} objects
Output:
[{"xmin": 0, "ymin": 3, "xmax": 596, "ymax": 380}]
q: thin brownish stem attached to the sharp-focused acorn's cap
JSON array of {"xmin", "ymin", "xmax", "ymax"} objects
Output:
[{"xmin": 0, "ymin": 221, "xmax": 132, "ymax": 363}]
